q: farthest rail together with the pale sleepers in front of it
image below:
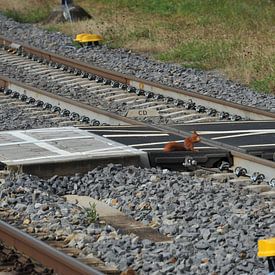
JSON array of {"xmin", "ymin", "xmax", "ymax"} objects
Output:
[{"xmin": 0, "ymin": 37, "xmax": 275, "ymax": 124}]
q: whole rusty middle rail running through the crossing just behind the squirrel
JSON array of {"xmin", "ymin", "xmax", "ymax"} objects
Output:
[{"xmin": 0, "ymin": 76, "xmax": 275, "ymax": 180}]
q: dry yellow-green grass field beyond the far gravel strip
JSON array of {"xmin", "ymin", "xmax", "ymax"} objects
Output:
[{"xmin": 0, "ymin": 0, "xmax": 275, "ymax": 93}]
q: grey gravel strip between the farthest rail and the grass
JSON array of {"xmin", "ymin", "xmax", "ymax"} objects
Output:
[{"xmin": 0, "ymin": 14, "xmax": 275, "ymax": 112}]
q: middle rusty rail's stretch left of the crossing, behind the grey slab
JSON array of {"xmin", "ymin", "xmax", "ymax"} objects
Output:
[{"xmin": 0, "ymin": 76, "xmax": 141, "ymax": 125}]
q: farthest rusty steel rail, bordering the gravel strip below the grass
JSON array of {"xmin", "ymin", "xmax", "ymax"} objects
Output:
[{"xmin": 0, "ymin": 36, "xmax": 275, "ymax": 120}]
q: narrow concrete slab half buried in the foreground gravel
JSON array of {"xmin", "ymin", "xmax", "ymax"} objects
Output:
[{"xmin": 65, "ymin": 195, "xmax": 172, "ymax": 242}]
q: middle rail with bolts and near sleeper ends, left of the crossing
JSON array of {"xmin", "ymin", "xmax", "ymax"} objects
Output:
[{"xmin": 0, "ymin": 77, "xmax": 139, "ymax": 129}]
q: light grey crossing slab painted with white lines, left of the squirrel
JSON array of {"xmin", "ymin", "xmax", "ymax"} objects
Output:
[{"xmin": 0, "ymin": 127, "xmax": 149, "ymax": 178}]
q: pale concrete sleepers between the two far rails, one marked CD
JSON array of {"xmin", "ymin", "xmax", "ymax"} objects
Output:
[{"xmin": 1, "ymin": 46, "xmax": 229, "ymax": 123}]
